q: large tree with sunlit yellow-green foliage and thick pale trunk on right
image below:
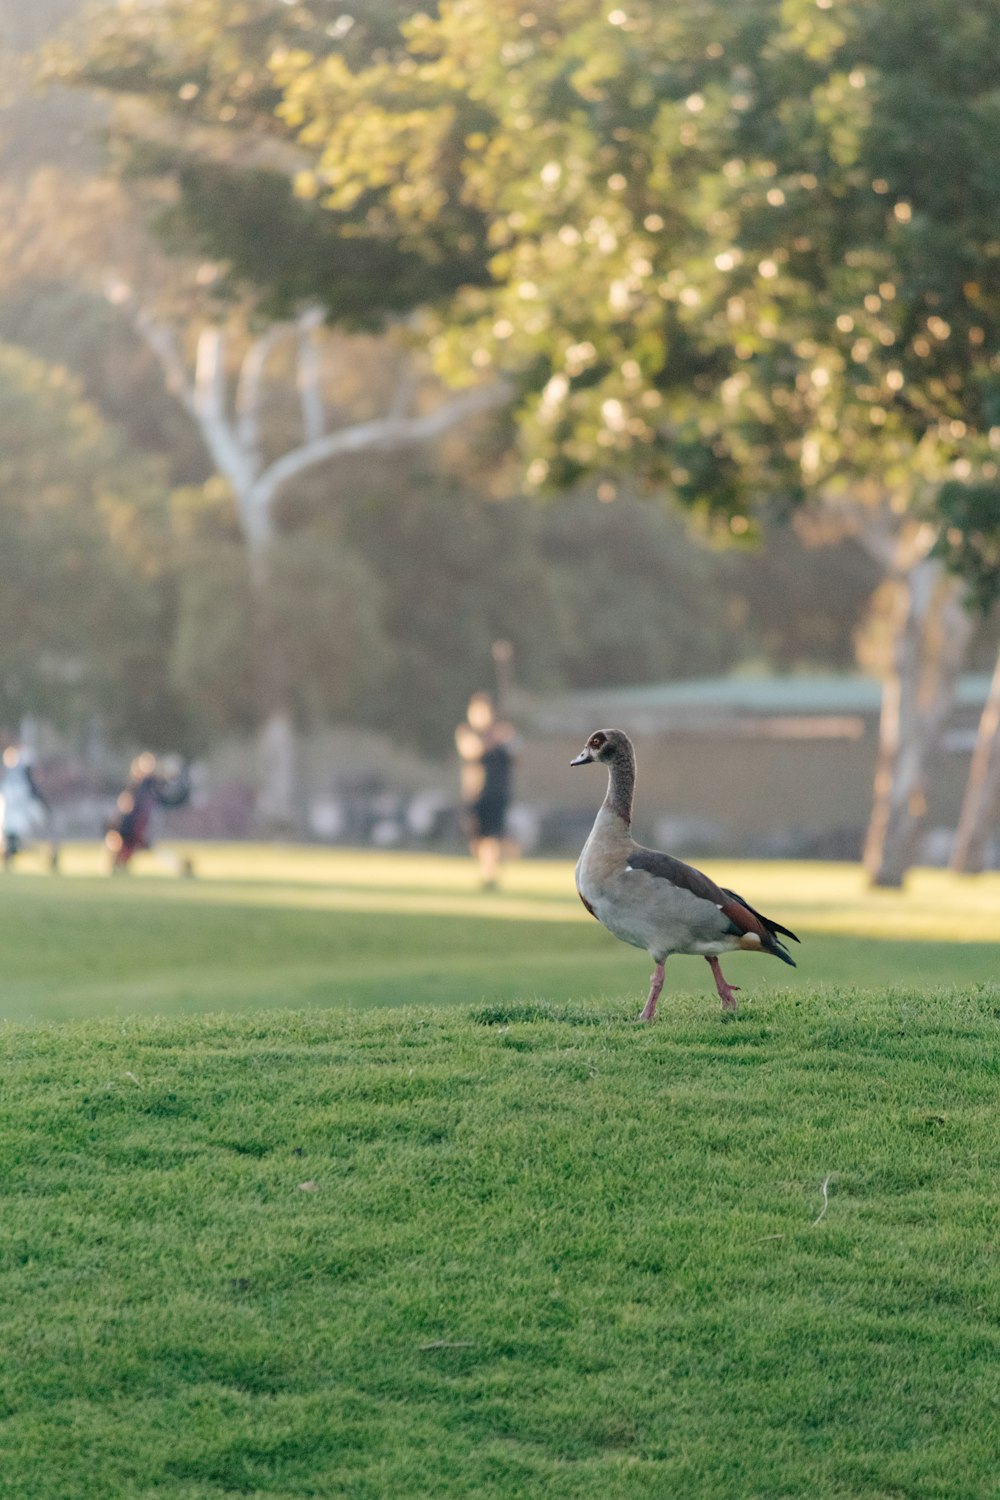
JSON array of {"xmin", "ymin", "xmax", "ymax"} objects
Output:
[{"xmin": 229, "ymin": 0, "xmax": 1000, "ymax": 884}]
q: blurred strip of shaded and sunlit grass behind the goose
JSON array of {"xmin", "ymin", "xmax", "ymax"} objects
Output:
[{"xmin": 0, "ymin": 845, "xmax": 1000, "ymax": 1020}]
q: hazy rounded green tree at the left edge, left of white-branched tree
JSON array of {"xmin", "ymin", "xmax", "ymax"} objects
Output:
[{"xmin": 0, "ymin": 345, "xmax": 189, "ymax": 749}]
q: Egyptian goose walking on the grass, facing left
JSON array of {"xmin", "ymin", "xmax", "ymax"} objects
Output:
[{"xmin": 570, "ymin": 729, "xmax": 799, "ymax": 1022}]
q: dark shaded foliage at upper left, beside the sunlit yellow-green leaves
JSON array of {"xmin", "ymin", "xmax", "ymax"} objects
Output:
[{"xmin": 45, "ymin": 0, "xmax": 486, "ymax": 327}]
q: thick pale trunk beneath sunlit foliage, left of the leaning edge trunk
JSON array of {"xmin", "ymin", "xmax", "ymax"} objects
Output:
[{"xmin": 864, "ymin": 557, "xmax": 972, "ymax": 887}]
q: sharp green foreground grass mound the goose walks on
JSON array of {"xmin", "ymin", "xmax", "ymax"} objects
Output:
[{"xmin": 0, "ymin": 990, "xmax": 1000, "ymax": 1500}]
